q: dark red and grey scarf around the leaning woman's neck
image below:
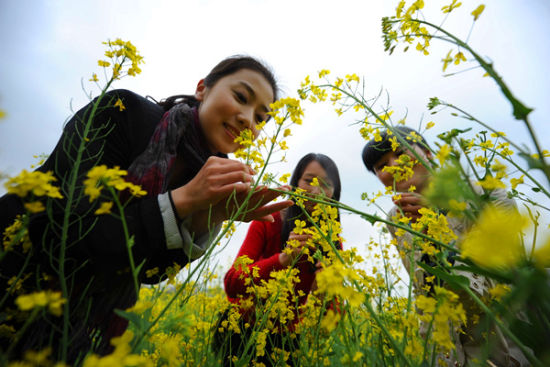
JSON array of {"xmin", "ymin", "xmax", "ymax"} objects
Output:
[{"xmin": 127, "ymin": 103, "xmax": 227, "ymax": 197}]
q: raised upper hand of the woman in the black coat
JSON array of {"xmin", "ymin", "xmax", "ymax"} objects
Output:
[{"xmin": 172, "ymin": 157, "xmax": 255, "ymax": 218}]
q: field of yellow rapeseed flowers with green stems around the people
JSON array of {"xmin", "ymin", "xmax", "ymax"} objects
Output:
[{"xmin": 0, "ymin": 0, "xmax": 550, "ymax": 367}]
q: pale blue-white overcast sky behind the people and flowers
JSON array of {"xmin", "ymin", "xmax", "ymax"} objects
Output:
[{"xmin": 0, "ymin": 0, "xmax": 550, "ymax": 288}]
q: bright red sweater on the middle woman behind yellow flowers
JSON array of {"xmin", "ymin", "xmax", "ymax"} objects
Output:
[{"xmin": 224, "ymin": 212, "xmax": 315, "ymax": 316}]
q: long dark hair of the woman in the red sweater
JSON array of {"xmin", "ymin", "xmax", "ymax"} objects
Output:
[{"xmin": 281, "ymin": 153, "xmax": 342, "ymax": 248}]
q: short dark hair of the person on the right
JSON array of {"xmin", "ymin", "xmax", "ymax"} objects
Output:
[{"xmin": 361, "ymin": 125, "xmax": 430, "ymax": 173}]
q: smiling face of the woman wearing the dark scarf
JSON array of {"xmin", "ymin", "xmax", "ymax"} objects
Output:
[{"xmin": 195, "ymin": 69, "xmax": 274, "ymax": 154}]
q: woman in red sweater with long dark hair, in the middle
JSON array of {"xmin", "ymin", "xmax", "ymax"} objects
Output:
[{"xmin": 214, "ymin": 153, "xmax": 341, "ymax": 366}]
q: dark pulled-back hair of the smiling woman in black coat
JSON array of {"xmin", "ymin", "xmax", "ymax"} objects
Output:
[{"xmin": 158, "ymin": 55, "xmax": 279, "ymax": 111}]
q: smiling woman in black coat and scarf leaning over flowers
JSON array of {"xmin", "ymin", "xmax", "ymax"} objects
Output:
[{"xmin": 0, "ymin": 56, "xmax": 292, "ymax": 363}]
